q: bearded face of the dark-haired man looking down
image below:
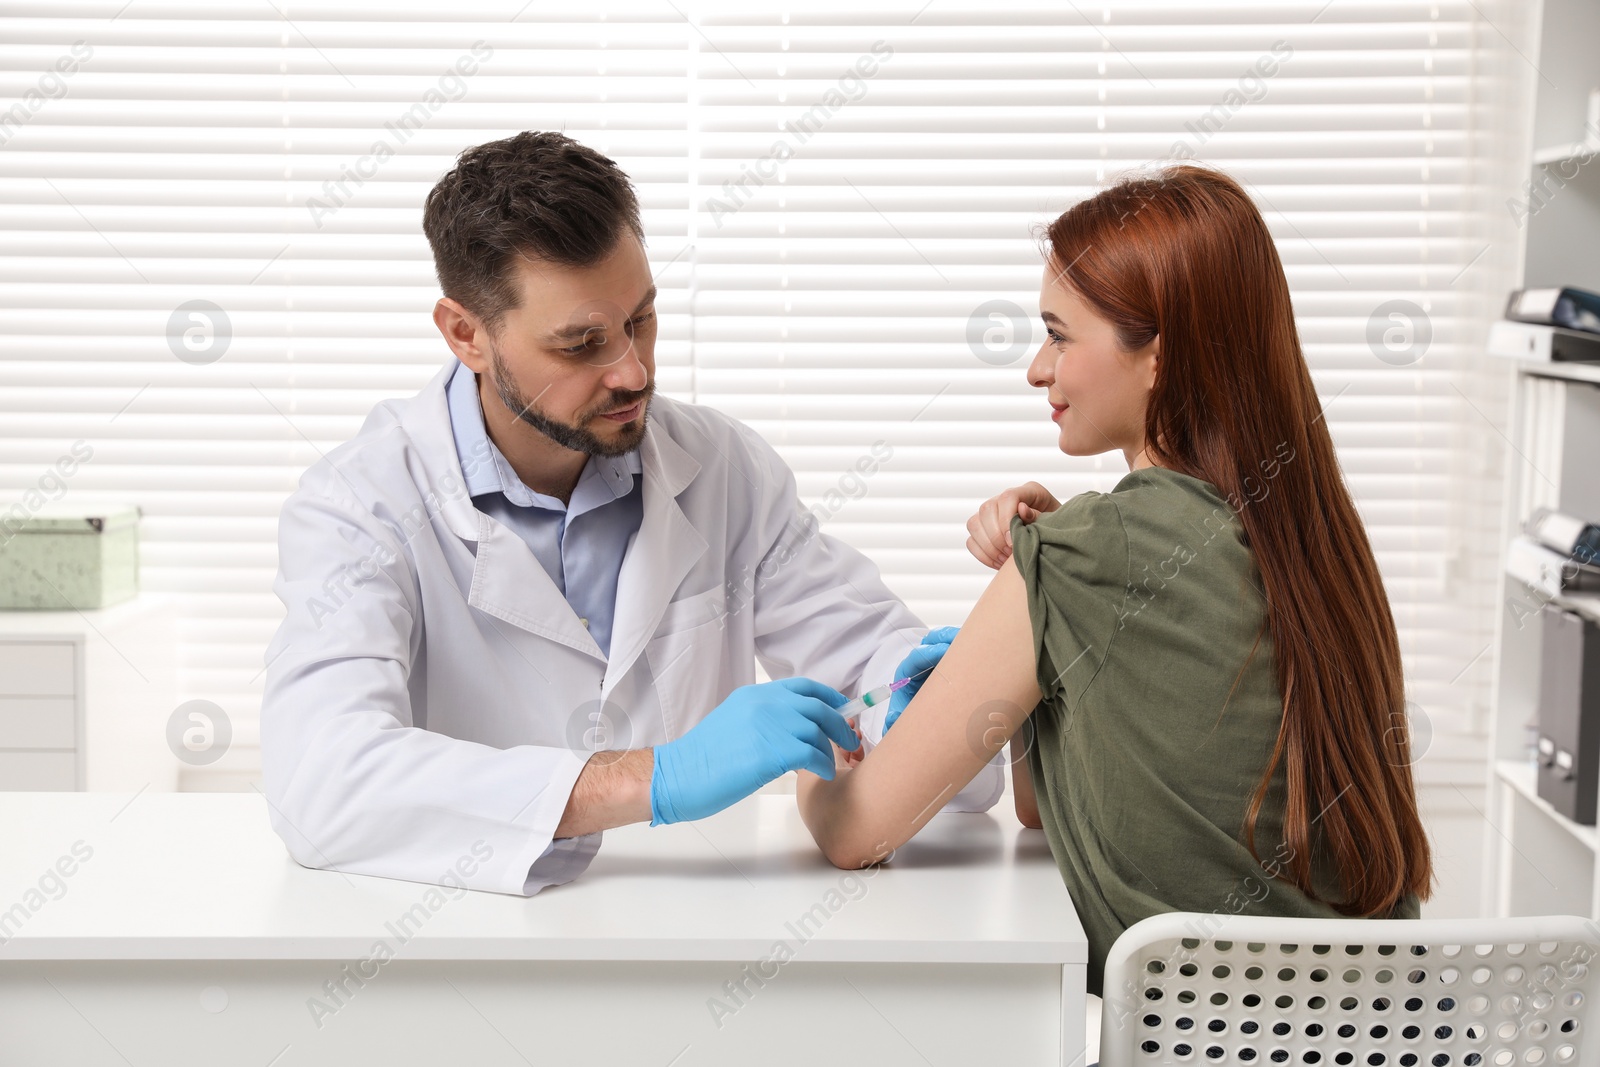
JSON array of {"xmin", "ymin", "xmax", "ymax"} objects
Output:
[{"xmin": 490, "ymin": 234, "xmax": 656, "ymax": 456}]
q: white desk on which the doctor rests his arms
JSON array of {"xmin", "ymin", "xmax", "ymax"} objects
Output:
[{"xmin": 0, "ymin": 792, "xmax": 1088, "ymax": 1067}]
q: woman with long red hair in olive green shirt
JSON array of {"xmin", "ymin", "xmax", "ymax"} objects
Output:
[{"xmin": 798, "ymin": 166, "xmax": 1432, "ymax": 993}]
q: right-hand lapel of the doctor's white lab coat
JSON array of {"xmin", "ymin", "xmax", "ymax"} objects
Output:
[{"xmin": 603, "ymin": 419, "xmax": 707, "ymax": 693}]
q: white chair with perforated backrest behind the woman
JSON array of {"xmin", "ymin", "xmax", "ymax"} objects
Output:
[{"xmin": 1099, "ymin": 912, "xmax": 1600, "ymax": 1067}]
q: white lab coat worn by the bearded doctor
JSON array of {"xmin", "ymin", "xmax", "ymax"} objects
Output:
[{"xmin": 261, "ymin": 362, "xmax": 1003, "ymax": 894}]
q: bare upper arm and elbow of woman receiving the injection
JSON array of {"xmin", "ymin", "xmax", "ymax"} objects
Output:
[{"xmin": 797, "ymin": 560, "xmax": 1040, "ymax": 869}]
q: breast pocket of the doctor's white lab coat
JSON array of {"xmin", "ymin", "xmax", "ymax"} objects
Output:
[{"xmin": 645, "ymin": 589, "xmax": 733, "ymax": 741}]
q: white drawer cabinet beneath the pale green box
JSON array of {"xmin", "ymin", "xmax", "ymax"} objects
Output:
[{"xmin": 0, "ymin": 593, "xmax": 179, "ymax": 792}]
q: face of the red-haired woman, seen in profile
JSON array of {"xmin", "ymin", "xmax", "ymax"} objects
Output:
[{"xmin": 1027, "ymin": 264, "xmax": 1162, "ymax": 469}]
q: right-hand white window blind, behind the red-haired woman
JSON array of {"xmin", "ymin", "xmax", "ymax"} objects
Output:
[{"xmin": 691, "ymin": 2, "xmax": 1510, "ymax": 779}]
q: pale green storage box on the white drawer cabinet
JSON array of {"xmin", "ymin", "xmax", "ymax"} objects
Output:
[{"xmin": 0, "ymin": 504, "xmax": 141, "ymax": 611}]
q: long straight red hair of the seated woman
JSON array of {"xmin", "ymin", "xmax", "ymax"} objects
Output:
[{"xmin": 1048, "ymin": 165, "xmax": 1432, "ymax": 915}]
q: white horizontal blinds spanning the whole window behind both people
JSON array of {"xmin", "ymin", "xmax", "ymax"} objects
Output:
[{"xmin": 0, "ymin": 0, "xmax": 1504, "ymax": 776}]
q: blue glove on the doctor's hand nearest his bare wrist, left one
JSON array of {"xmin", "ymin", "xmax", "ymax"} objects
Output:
[{"xmin": 650, "ymin": 678, "xmax": 861, "ymax": 825}]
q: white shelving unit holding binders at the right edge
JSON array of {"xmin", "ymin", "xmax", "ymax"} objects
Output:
[{"xmin": 1485, "ymin": 0, "xmax": 1600, "ymax": 918}]
